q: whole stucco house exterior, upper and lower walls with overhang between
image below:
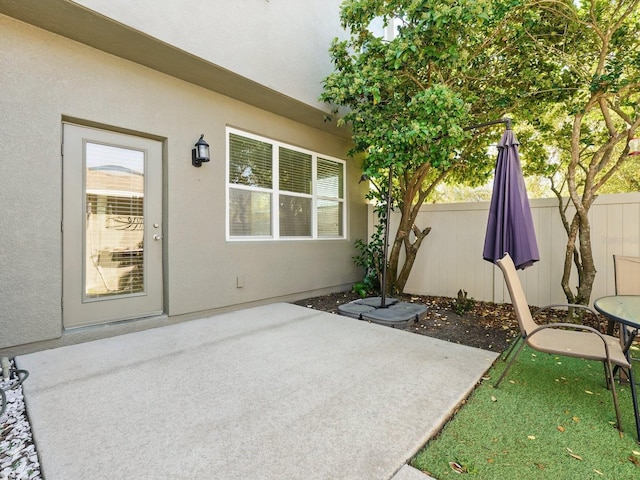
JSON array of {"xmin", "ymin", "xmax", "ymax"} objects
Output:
[{"xmin": 0, "ymin": 0, "xmax": 367, "ymax": 354}]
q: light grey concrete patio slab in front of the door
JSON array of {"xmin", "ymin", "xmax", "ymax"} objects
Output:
[{"xmin": 16, "ymin": 303, "xmax": 496, "ymax": 480}]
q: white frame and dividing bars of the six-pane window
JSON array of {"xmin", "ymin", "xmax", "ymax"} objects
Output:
[{"xmin": 225, "ymin": 127, "xmax": 347, "ymax": 242}]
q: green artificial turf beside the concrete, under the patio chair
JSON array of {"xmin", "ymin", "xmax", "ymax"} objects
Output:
[{"xmin": 411, "ymin": 347, "xmax": 640, "ymax": 480}]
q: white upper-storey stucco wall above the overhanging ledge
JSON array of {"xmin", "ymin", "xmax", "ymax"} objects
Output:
[{"xmin": 75, "ymin": 0, "xmax": 345, "ymax": 109}]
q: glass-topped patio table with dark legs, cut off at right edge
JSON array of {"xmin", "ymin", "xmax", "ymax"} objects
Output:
[{"xmin": 593, "ymin": 295, "xmax": 640, "ymax": 443}]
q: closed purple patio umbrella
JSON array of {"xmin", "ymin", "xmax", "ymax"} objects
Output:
[{"xmin": 482, "ymin": 128, "xmax": 540, "ymax": 269}]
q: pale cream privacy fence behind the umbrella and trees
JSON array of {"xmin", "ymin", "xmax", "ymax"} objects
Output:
[{"xmin": 369, "ymin": 193, "xmax": 640, "ymax": 306}]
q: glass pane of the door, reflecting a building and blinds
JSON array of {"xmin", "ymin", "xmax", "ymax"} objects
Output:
[{"xmin": 84, "ymin": 143, "xmax": 144, "ymax": 299}]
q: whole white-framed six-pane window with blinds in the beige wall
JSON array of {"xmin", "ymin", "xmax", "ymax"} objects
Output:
[{"xmin": 227, "ymin": 128, "xmax": 345, "ymax": 240}]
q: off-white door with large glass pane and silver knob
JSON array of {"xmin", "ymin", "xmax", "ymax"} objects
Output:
[{"xmin": 62, "ymin": 124, "xmax": 163, "ymax": 328}]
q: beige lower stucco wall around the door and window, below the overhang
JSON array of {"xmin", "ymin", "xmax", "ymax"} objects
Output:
[{"xmin": 0, "ymin": 15, "xmax": 367, "ymax": 348}]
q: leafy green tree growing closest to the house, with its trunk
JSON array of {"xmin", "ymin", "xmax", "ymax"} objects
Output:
[{"xmin": 321, "ymin": 0, "xmax": 520, "ymax": 291}]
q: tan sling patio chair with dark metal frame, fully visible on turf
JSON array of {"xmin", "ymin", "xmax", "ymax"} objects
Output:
[{"xmin": 494, "ymin": 254, "xmax": 631, "ymax": 431}]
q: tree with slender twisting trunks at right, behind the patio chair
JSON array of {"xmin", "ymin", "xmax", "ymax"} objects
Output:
[{"xmin": 510, "ymin": 0, "xmax": 640, "ymax": 303}]
